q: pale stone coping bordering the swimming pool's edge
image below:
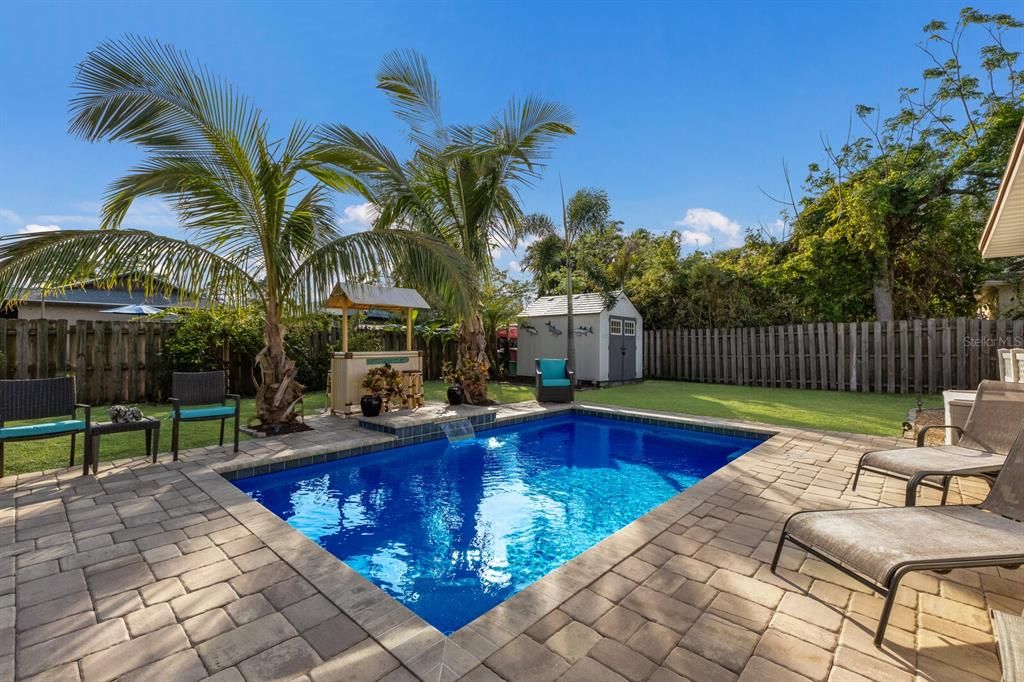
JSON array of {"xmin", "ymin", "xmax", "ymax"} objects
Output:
[{"xmin": 190, "ymin": 403, "xmax": 793, "ymax": 679}]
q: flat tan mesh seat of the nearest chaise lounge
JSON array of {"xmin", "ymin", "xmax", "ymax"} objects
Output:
[{"xmin": 786, "ymin": 505, "xmax": 1024, "ymax": 586}]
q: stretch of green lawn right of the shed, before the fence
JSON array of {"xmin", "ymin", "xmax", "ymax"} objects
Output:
[{"xmin": 577, "ymin": 381, "xmax": 942, "ymax": 436}]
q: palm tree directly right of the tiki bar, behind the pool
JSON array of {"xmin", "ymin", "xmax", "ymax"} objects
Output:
[{"xmin": 321, "ymin": 51, "xmax": 574, "ymax": 403}]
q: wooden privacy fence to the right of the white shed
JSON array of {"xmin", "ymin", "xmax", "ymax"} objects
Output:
[{"xmin": 643, "ymin": 317, "xmax": 1024, "ymax": 393}]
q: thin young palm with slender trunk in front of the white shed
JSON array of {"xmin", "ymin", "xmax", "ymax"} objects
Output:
[{"xmin": 523, "ymin": 188, "xmax": 611, "ymax": 382}]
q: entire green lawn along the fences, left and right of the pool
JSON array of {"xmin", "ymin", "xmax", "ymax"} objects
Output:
[{"xmin": 6, "ymin": 381, "xmax": 942, "ymax": 473}]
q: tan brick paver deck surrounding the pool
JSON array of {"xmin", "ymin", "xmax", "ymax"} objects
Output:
[{"xmin": 0, "ymin": 404, "xmax": 1024, "ymax": 682}]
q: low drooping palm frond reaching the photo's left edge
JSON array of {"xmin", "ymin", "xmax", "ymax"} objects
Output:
[{"xmin": 0, "ymin": 229, "xmax": 261, "ymax": 305}]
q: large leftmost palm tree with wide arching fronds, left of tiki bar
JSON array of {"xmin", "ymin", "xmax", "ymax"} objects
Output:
[{"xmin": 0, "ymin": 38, "xmax": 477, "ymax": 424}]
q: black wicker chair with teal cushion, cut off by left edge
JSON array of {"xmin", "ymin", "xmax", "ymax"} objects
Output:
[{"xmin": 0, "ymin": 377, "xmax": 92, "ymax": 476}]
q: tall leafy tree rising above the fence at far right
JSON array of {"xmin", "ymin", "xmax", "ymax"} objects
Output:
[{"xmin": 786, "ymin": 8, "xmax": 1024, "ymax": 319}]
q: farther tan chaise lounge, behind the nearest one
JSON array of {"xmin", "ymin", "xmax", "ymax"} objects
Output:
[{"xmin": 853, "ymin": 381, "xmax": 1024, "ymax": 507}]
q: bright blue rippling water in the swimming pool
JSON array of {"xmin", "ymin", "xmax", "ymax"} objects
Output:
[{"xmin": 234, "ymin": 415, "xmax": 760, "ymax": 634}]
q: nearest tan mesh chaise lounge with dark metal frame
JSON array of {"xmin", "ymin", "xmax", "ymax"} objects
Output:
[{"xmin": 771, "ymin": 423, "xmax": 1024, "ymax": 647}]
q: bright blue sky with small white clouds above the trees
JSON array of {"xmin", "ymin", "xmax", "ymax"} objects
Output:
[{"xmin": 0, "ymin": 0, "xmax": 1024, "ymax": 270}]
